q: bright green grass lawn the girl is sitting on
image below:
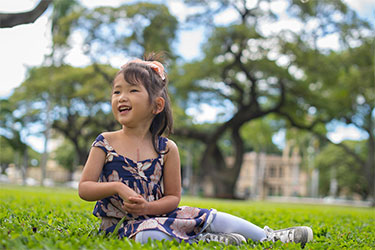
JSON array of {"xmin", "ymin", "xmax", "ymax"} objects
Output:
[{"xmin": 0, "ymin": 185, "xmax": 375, "ymax": 250}]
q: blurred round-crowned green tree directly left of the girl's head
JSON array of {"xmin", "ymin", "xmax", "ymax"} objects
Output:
[{"xmin": 11, "ymin": 65, "xmax": 115, "ymax": 169}]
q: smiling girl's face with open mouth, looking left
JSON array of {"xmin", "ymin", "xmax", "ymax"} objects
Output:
[{"xmin": 112, "ymin": 74, "xmax": 154, "ymax": 128}]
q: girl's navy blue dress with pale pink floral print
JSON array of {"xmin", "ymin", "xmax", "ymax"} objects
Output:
[{"xmin": 92, "ymin": 135, "xmax": 216, "ymax": 242}]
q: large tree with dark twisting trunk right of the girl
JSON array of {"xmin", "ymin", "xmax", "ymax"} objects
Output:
[{"xmin": 173, "ymin": 0, "xmax": 371, "ymax": 197}]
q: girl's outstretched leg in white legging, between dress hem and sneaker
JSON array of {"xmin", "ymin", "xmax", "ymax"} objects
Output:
[{"xmin": 206, "ymin": 212, "xmax": 267, "ymax": 241}]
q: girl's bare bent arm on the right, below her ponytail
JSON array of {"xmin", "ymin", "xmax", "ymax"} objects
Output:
[{"xmin": 124, "ymin": 140, "xmax": 181, "ymax": 215}]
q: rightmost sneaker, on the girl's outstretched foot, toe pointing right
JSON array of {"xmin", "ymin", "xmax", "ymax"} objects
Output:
[{"xmin": 264, "ymin": 226, "xmax": 313, "ymax": 248}]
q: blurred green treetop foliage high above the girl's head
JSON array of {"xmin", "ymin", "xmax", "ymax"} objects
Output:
[{"xmin": 61, "ymin": 2, "xmax": 178, "ymax": 59}]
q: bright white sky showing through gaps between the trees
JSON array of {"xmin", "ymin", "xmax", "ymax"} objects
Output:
[{"xmin": 0, "ymin": 0, "xmax": 375, "ymax": 150}]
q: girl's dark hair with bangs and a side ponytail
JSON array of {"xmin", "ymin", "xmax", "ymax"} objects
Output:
[{"xmin": 116, "ymin": 52, "xmax": 173, "ymax": 154}]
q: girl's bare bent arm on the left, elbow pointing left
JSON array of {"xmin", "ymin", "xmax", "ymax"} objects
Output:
[{"xmin": 78, "ymin": 147, "xmax": 138, "ymax": 201}]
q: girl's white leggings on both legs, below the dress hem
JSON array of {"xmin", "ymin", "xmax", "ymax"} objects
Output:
[{"xmin": 135, "ymin": 212, "xmax": 266, "ymax": 243}]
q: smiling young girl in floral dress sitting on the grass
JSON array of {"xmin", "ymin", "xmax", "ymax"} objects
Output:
[{"xmin": 79, "ymin": 54, "xmax": 313, "ymax": 246}]
